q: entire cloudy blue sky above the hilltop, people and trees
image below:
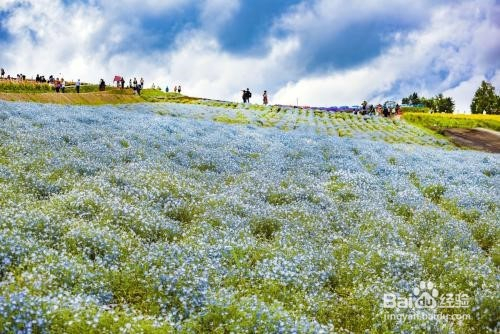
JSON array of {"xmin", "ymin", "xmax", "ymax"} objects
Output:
[{"xmin": 0, "ymin": 0, "xmax": 500, "ymax": 112}]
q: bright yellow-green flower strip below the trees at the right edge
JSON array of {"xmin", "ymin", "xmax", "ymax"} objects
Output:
[{"xmin": 403, "ymin": 113, "xmax": 500, "ymax": 131}]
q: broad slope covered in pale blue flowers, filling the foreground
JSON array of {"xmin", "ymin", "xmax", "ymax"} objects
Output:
[{"xmin": 0, "ymin": 103, "xmax": 500, "ymax": 333}]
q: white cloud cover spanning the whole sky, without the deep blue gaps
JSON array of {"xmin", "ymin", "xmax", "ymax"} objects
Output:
[{"xmin": 0, "ymin": 0, "xmax": 500, "ymax": 110}]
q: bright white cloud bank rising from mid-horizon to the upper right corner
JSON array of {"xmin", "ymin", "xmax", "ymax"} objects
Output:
[{"xmin": 277, "ymin": 1, "xmax": 500, "ymax": 110}]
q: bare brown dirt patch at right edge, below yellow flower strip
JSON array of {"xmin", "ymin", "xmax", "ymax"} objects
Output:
[{"xmin": 443, "ymin": 128, "xmax": 500, "ymax": 153}]
